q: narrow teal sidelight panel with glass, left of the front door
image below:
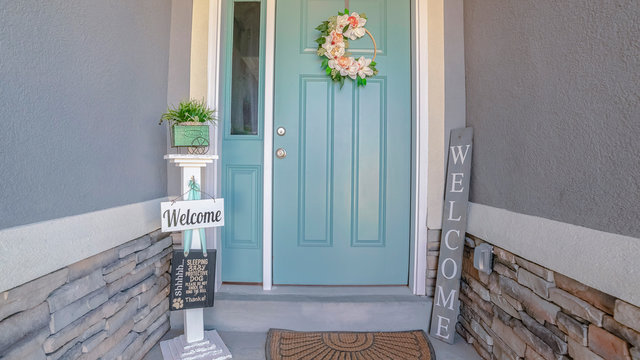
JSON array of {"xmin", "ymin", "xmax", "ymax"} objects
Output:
[{"xmin": 220, "ymin": 0, "xmax": 271, "ymax": 283}]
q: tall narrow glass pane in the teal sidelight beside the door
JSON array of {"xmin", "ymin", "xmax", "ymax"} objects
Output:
[{"xmin": 231, "ymin": 2, "xmax": 260, "ymax": 135}]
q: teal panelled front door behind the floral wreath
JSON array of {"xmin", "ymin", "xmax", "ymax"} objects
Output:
[{"xmin": 273, "ymin": 0, "xmax": 411, "ymax": 285}]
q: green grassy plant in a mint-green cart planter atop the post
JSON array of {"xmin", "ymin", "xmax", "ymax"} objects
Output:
[{"xmin": 160, "ymin": 99, "xmax": 217, "ymax": 154}]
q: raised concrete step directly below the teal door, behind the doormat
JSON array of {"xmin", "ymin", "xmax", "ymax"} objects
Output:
[{"xmin": 204, "ymin": 285, "xmax": 432, "ymax": 332}]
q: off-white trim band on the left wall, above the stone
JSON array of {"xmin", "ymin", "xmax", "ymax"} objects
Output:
[{"xmin": 0, "ymin": 198, "xmax": 168, "ymax": 292}]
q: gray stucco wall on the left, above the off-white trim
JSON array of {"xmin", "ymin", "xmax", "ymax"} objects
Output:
[{"xmin": 0, "ymin": 0, "xmax": 171, "ymax": 229}]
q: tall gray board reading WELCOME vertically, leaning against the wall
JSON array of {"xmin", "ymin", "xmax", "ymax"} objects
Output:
[{"xmin": 430, "ymin": 128, "xmax": 473, "ymax": 344}]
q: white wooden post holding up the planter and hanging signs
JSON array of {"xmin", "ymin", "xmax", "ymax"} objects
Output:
[{"xmin": 164, "ymin": 154, "xmax": 218, "ymax": 343}]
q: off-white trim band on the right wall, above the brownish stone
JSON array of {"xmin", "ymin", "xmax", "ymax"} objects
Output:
[{"xmin": 467, "ymin": 203, "xmax": 640, "ymax": 305}]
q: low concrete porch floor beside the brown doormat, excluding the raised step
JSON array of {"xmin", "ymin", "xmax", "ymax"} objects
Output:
[{"xmin": 144, "ymin": 330, "xmax": 480, "ymax": 360}]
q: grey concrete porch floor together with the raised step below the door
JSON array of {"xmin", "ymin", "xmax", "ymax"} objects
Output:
[{"xmin": 144, "ymin": 285, "xmax": 480, "ymax": 360}]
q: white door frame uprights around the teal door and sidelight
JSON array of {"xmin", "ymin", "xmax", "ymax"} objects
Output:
[{"xmin": 207, "ymin": 0, "xmax": 429, "ymax": 295}]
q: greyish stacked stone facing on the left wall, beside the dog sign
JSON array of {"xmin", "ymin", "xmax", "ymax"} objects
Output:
[{"xmin": 0, "ymin": 231, "xmax": 172, "ymax": 360}]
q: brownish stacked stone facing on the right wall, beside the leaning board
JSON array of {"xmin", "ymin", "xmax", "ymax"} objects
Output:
[{"xmin": 456, "ymin": 237, "xmax": 640, "ymax": 360}]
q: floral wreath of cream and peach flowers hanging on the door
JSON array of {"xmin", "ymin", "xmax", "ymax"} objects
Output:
[{"xmin": 316, "ymin": 9, "xmax": 378, "ymax": 87}]
